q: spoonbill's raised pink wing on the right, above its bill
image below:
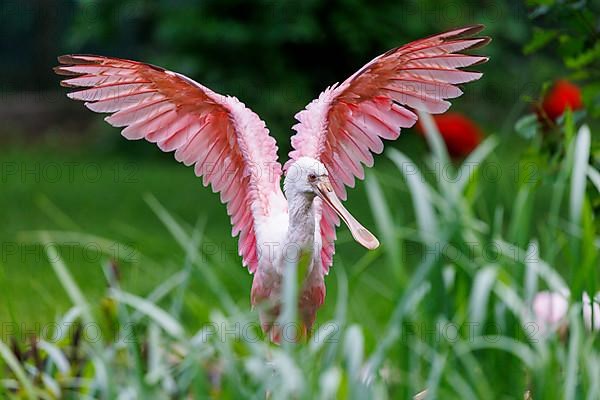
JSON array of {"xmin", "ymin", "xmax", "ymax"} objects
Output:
[{"xmin": 286, "ymin": 25, "xmax": 490, "ymax": 272}]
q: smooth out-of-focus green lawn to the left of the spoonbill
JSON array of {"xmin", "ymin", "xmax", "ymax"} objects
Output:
[{"xmin": 0, "ymin": 144, "xmax": 239, "ymax": 323}]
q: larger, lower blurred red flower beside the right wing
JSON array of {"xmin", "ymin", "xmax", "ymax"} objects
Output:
[{"xmin": 417, "ymin": 112, "xmax": 483, "ymax": 157}]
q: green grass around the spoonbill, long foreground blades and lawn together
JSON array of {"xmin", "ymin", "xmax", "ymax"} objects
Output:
[{"xmin": 0, "ymin": 116, "xmax": 600, "ymax": 399}]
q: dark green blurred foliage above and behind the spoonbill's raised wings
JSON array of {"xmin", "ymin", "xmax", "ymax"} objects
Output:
[{"xmin": 0, "ymin": 0, "xmax": 577, "ymax": 139}]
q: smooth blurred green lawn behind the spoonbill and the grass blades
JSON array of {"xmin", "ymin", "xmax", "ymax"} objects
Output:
[{"xmin": 0, "ymin": 143, "xmax": 393, "ymax": 330}]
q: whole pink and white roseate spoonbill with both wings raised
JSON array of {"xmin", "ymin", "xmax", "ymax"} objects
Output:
[{"xmin": 55, "ymin": 25, "xmax": 490, "ymax": 341}]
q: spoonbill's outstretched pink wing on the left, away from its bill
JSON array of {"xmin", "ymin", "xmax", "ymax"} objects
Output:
[{"xmin": 55, "ymin": 55, "xmax": 287, "ymax": 272}]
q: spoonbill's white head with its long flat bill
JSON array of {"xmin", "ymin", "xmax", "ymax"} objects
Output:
[{"xmin": 283, "ymin": 157, "xmax": 379, "ymax": 250}]
